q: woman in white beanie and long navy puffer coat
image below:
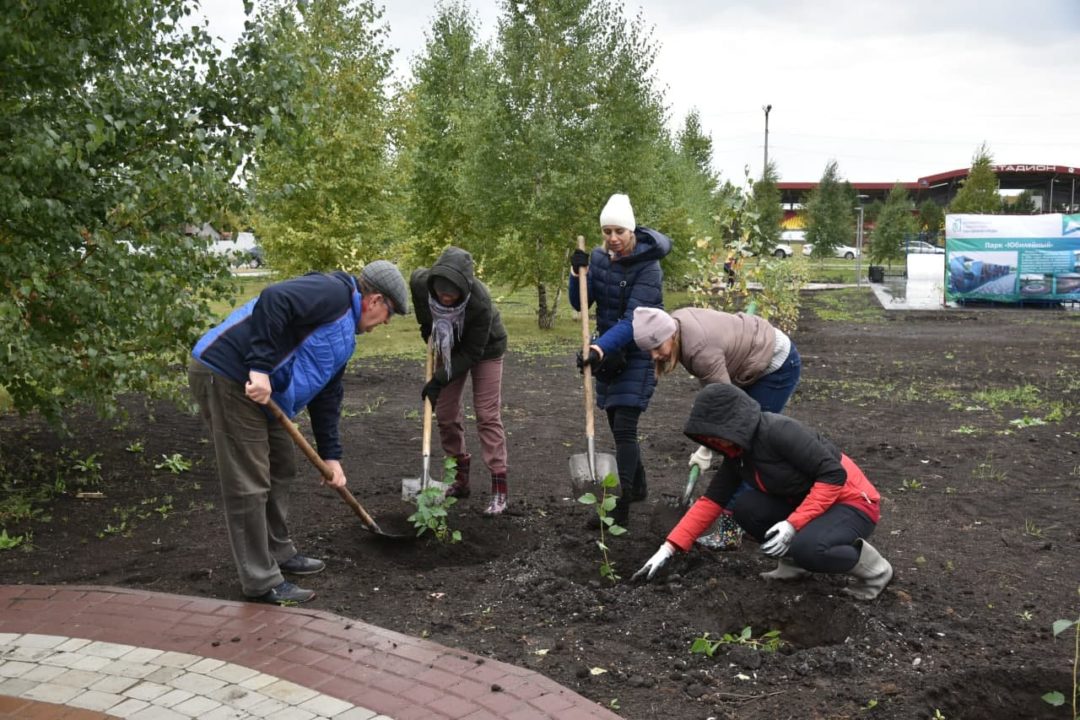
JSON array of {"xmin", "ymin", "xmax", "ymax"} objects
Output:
[{"xmin": 570, "ymin": 193, "xmax": 672, "ymax": 527}]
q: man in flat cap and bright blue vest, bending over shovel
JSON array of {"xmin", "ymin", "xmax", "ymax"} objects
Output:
[{"xmin": 188, "ymin": 260, "xmax": 408, "ymax": 604}]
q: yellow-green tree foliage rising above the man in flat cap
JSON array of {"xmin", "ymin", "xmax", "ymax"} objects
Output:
[{"xmin": 253, "ymin": 0, "xmax": 401, "ymax": 275}]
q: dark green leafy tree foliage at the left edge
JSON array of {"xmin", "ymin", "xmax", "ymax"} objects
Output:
[{"xmin": 0, "ymin": 0, "xmax": 295, "ymax": 423}]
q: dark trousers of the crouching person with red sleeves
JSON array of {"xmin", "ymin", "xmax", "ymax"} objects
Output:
[{"xmin": 728, "ymin": 488, "xmax": 875, "ymax": 573}]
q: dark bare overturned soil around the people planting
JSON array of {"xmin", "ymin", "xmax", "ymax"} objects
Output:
[{"xmin": 0, "ymin": 291, "xmax": 1080, "ymax": 720}]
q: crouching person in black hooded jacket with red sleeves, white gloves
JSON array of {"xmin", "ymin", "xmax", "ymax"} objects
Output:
[{"xmin": 634, "ymin": 383, "xmax": 892, "ymax": 600}]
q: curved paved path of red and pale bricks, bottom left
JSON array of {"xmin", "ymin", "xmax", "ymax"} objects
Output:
[{"xmin": 0, "ymin": 585, "xmax": 618, "ymax": 720}]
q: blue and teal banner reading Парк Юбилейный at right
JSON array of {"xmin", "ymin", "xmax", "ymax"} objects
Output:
[{"xmin": 945, "ymin": 214, "xmax": 1080, "ymax": 302}]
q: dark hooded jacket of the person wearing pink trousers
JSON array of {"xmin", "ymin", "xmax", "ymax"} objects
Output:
[{"xmin": 409, "ymin": 246, "xmax": 507, "ymax": 382}]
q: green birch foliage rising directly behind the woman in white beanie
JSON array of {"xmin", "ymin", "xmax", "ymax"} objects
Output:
[{"xmin": 455, "ymin": 0, "xmax": 672, "ymax": 328}]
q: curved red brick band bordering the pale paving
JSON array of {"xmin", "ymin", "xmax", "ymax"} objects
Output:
[{"xmin": 0, "ymin": 585, "xmax": 619, "ymax": 720}]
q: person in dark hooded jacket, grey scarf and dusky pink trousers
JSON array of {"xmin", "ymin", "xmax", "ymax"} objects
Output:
[{"xmin": 409, "ymin": 246, "xmax": 509, "ymax": 516}]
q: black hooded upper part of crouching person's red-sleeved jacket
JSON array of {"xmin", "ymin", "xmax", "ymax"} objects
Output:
[{"xmin": 684, "ymin": 383, "xmax": 848, "ymax": 510}]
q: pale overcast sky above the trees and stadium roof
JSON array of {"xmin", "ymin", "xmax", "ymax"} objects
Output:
[{"xmin": 203, "ymin": 0, "xmax": 1080, "ymax": 182}]
